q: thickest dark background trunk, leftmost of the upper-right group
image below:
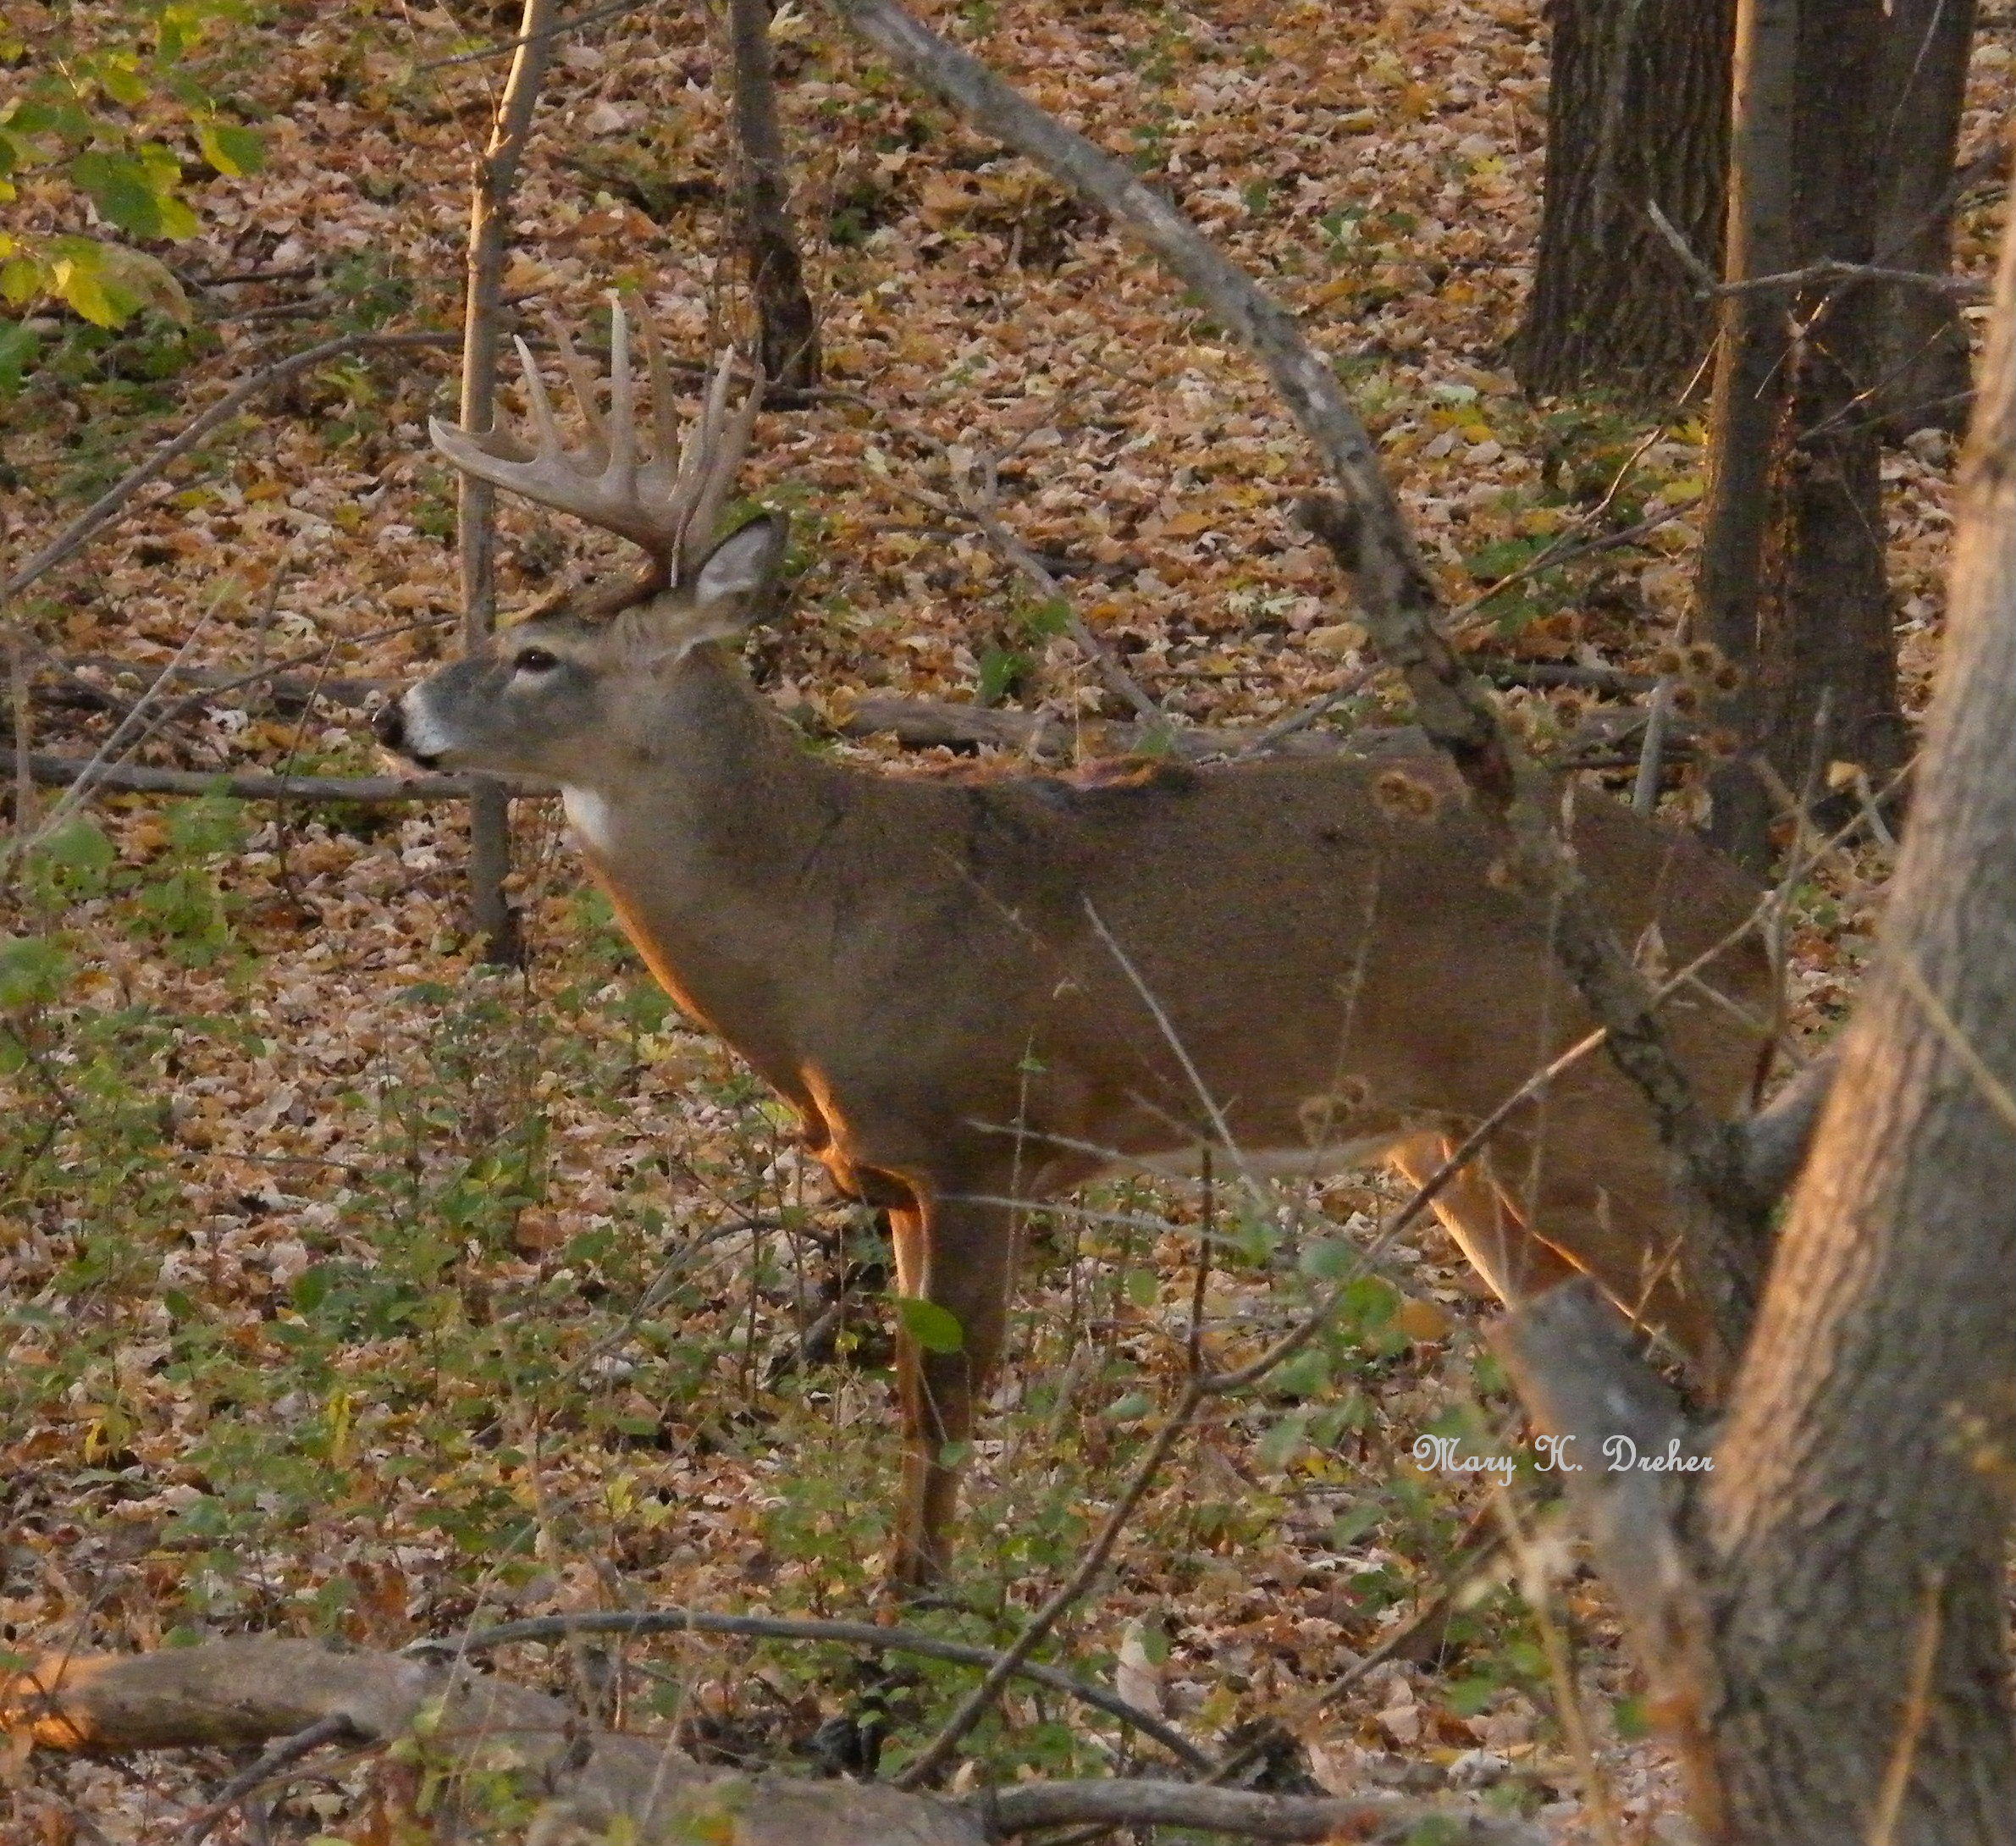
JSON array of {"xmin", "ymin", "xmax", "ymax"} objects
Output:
[{"xmin": 1514, "ymin": 0, "xmax": 1736, "ymax": 403}]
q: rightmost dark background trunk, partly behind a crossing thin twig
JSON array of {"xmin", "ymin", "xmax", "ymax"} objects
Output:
[{"xmin": 1877, "ymin": 0, "xmax": 1974, "ymax": 441}]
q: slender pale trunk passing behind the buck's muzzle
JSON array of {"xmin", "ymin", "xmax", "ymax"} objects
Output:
[{"xmin": 456, "ymin": 0, "xmax": 559, "ymax": 961}]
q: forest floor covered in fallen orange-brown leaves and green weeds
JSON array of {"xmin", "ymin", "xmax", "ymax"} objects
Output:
[{"xmin": 0, "ymin": 0, "xmax": 2016, "ymax": 1846}]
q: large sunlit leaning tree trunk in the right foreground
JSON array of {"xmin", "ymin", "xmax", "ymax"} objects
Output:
[{"xmin": 1704, "ymin": 183, "xmax": 2016, "ymax": 1846}]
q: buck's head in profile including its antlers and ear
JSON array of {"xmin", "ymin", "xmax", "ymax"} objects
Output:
[{"xmin": 377, "ymin": 301, "xmax": 787, "ymax": 786}]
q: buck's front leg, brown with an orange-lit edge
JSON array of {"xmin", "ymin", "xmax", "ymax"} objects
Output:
[{"xmin": 889, "ymin": 1187, "xmax": 1016, "ymax": 1590}]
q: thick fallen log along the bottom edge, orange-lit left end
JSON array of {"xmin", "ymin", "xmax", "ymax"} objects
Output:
[{"xmin": 0, "ymin": 1636, "xmax": 1542, "ymax": 1846}]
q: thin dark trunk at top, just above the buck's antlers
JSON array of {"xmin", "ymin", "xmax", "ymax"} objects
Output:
[{"xmin": 728, "ymin": 0, "xmax": 819, "ymax": 389}]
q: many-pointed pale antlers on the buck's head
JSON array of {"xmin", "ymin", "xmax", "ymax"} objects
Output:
[{"xmin": 428, "ymin": 294, "xmax": 764, "ymax": 584}]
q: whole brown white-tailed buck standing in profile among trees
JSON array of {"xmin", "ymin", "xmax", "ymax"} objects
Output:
[{"xmin": 379, "ymin": 307, "xmax": 1768, "ymax": 1582}]
